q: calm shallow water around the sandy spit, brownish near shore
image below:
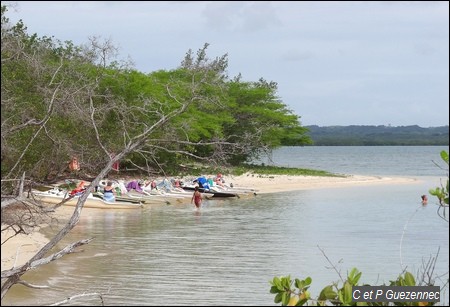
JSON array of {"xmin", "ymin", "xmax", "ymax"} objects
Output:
[{"xmin": 2, "ymin": 147, "xmax": 449, "ymax": 306}]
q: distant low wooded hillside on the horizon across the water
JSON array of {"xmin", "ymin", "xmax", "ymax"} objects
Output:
[{"xmin": 305, "ymin": 125, "xmax": 449, "ymax": 146}]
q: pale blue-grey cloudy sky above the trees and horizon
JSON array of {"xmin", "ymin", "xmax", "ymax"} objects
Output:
[{"xmin": 2, "ymin": 1, "xmax": 449, "ymax": 127}]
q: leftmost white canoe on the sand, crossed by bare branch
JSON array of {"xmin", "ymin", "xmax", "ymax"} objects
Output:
[{"xmin": 32, "ymin": 190, "xmax": 143, "ymax": 209}]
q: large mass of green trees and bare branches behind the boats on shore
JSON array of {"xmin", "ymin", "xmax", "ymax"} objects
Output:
[{"xmin": 1, "ymin": 6, "xmax": 310, "ymax": 186}]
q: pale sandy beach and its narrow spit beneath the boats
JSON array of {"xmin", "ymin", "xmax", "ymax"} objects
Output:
[{"xmin": 1, "ymin": 174, "xmax": 417, "ymax": 271}]
